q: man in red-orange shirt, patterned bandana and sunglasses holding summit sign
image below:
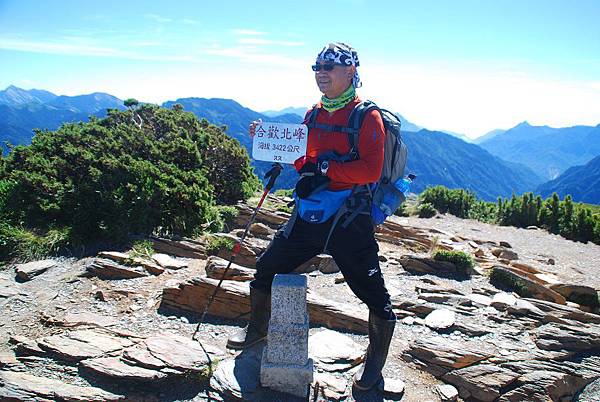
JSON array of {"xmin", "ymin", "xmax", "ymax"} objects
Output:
[{"xmin": 227, "ymin": 42, "xmax": 396, "ymax": 390}]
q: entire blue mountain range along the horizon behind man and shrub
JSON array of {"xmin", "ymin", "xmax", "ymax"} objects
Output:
[{"xmin": 0, "ymin": 86, "xmax": 600, "ymax": 203}]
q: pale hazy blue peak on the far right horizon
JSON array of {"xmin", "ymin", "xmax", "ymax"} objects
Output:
[{"xmin": 478, "ymin": 122, "xmax": 600, "ymax": 180}]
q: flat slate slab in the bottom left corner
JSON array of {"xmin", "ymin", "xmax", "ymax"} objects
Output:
[{"xmin": 0, "ymin": 371, "xmax": 125, "ymax": 402}]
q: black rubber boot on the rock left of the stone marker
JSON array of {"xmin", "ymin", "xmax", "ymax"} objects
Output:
[{"xmin": 227, "ymin": 286, "xmax": 271, "ymax": 350}]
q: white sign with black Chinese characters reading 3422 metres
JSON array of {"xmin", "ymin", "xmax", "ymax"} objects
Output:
[{"xmin": 252, "ymin": 123, "xmax": 308, "ymax": 163}]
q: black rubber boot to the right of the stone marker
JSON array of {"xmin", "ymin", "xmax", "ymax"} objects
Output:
[{"xmin": 353, "ymin": 312, "xmax": 396, "ymax": 391}]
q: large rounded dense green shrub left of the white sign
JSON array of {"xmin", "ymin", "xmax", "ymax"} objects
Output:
[{"xmin": 0, "ymin": 105, "xmax": 258, "ymax": 258}]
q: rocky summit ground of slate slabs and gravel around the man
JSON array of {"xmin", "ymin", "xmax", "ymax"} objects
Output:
[{"xmin": 0, "ymin": 193, "xmax": 600, "ymax": 402}]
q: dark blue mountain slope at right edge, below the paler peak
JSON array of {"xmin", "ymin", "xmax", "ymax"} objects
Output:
[{"xmin": 537, "ymin": 155, "xmax": 600, "ymax": 204}]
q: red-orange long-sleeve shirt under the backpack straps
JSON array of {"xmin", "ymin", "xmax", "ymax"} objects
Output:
[{"xmin": 304, "ymin": 97, "xmax": 385, "ymax": 190}]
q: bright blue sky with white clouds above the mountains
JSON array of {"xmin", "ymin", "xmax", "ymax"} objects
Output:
[{"xmin": 0, "ymin": 0, "xmax": 600, "ymax": 137}]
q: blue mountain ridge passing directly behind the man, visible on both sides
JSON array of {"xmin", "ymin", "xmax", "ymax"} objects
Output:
[{"xmin": 163, "ymin": 98, "xmax": 543, "ymax": 201}]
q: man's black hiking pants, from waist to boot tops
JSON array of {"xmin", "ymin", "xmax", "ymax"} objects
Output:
[{"xmin": 251, "ymin": 215, "xmax": 395, "ymax": 320}]
